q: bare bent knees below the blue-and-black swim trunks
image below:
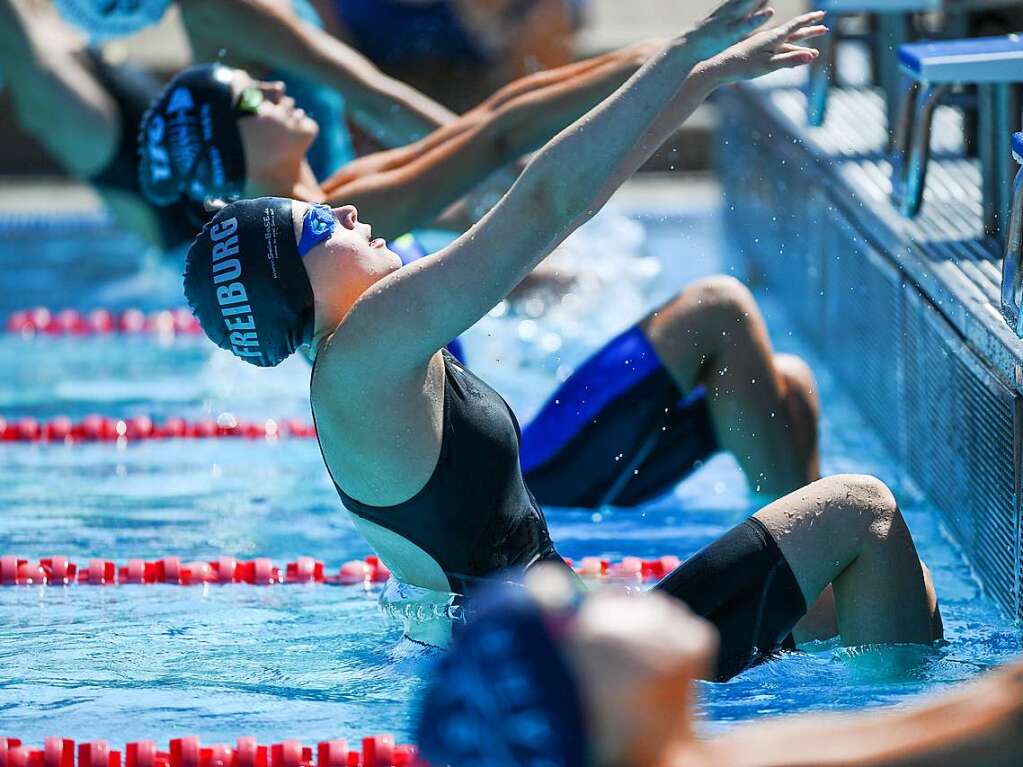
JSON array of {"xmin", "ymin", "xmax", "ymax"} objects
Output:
[{"xmin": 642, "ymin": 276, "xmax": 819, "ymax": 495}]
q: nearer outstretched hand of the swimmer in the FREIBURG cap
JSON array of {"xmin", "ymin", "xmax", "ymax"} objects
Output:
[{"xmin": 700, "ymin": 10, "xmax": 828, "ymax": 85}]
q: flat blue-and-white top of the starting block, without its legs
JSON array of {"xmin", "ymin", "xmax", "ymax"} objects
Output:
[{"xmin": 898, "ymin": 34, "xmax": 1023, "ymax": 83}]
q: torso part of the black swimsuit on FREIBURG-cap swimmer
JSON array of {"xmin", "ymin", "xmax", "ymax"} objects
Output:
[{"xmin": 335, "ymin": 350, "xmax": 562, "ymax": 594}]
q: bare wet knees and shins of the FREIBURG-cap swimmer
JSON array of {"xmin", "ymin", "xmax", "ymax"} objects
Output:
[{"xmin": 755, "ymin": 475, "xmax": 941, "ymax": 645}]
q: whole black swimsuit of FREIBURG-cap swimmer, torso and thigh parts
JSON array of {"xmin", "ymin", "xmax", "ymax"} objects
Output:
[{"xmin": 319, "ymin": 350, "xmax": 806, "ymax": 681}]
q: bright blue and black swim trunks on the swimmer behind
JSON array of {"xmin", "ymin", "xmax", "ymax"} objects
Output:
[{"xmin": 521, "ymin": 326, "xmax": 718, "ymax": 508}]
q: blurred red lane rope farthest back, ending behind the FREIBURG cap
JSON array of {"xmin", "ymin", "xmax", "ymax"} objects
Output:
[{"xmin": 4, "ymin": 307, "xmax": 203, "ymax": 339}]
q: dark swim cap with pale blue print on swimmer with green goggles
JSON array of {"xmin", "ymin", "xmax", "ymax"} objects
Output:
[{"xmin": 138, "ymin": 64, "xmax": 246, "ymax": 206}]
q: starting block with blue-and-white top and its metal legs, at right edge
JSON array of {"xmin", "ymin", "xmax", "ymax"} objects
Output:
[{"xmin": 892, "ymin": 35, "xmax": 1023, "ymax": 231}]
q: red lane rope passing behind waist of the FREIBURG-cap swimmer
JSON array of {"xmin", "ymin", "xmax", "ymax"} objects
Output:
[{"xmin": 0, "ymin": 555, "xmax": 680, "ymax": 589}]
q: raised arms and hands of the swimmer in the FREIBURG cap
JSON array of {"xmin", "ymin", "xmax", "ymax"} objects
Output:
[{"xmin": 320, "ymin": 0, "xmax": 824, "ymax": 375}]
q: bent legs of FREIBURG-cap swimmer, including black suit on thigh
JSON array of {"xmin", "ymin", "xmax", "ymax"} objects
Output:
[{"xmin": 656, "ymin": 475, "xmax": 941, "ymax": 680}]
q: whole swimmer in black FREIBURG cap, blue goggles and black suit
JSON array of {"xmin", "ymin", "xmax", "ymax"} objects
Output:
[{"xmin": 184, "ymin": 0, "xmax": 941, "ymax": 679}]
